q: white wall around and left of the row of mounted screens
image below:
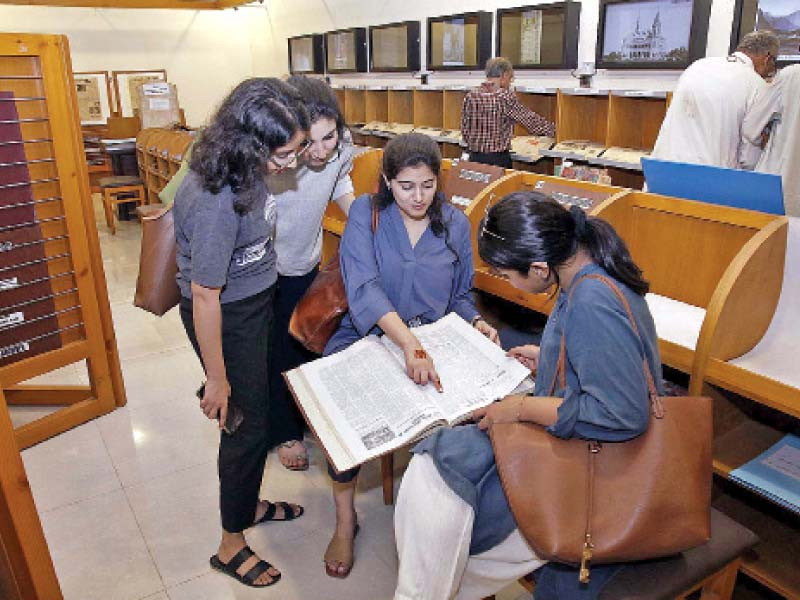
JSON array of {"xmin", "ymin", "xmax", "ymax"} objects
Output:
[{"xmin": 0, "ymin": 0, "xmax": 735, "ymax": 126}]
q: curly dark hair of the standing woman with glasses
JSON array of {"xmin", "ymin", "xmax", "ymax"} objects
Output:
[{"xmin": 191, "ymin": 77, "xmax": 309, "ymax": 212}]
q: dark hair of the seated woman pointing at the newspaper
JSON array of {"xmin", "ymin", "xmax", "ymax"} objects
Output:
[{"xmin": 373, "ymin": 133, "xmax": 458, "ymax": 259}]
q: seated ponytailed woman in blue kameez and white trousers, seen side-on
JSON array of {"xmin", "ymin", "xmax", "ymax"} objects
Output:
[{"xmin": 395, "ymin": 192, "xmax": 662, "ymax": 600}]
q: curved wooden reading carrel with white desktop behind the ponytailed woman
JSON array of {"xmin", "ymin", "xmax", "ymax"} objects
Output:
[{"xmin": 598, "ymin": 192, "xmax": 786, "ymax": 377}]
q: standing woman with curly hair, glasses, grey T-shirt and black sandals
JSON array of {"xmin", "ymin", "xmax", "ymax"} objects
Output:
[{"xmin": 173, "ymin": 78, "xmax": 308, "ymax": 587}]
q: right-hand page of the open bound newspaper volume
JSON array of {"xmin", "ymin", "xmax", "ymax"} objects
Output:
[{"xmin": 382, "ymin": 313, "xmax": 531, "ymax": 424}]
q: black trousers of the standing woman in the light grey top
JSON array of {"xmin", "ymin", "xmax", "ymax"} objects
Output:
[{"xmin": 269, "ymin": 268, "xmax": 318, "ymax": 445}]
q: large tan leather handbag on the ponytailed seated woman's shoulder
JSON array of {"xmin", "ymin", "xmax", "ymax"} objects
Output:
[{"xmin": 491, "ymin": 275, "xmax": 712, "ymax": 582}]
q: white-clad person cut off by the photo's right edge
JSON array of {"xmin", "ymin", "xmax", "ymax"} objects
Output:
[{"xmin": 743, "ymin": 65, "xmax": 800, "ymax": 217}]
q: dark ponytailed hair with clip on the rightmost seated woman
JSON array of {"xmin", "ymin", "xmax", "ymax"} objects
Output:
[{"xmin": 478, "ymin": 192, "xmax": 650, "ymax": 296}]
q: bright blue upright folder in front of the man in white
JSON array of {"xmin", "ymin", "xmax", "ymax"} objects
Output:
[{"xmin": 642, "ymin": 158, "xmax": 786, "ymax": 215}]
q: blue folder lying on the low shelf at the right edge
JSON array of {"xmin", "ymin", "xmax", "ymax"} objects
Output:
[{"xmin": 728, "ymin": 434, "xmax": 800, "ymax": 514}]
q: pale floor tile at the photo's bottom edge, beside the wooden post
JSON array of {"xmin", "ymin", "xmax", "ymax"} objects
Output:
[{"xmin": 41, "ymin": 490, "xmax": 164, "ymax": 600}]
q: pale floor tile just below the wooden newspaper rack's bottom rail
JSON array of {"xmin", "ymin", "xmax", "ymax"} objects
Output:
[{"xmin": 22, "ymin": 421, "xmax": 120, "ymax": 513}]
